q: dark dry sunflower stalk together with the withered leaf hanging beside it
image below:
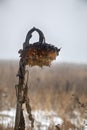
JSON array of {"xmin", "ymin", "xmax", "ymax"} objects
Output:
[{"xmin": 14, "ymin": 59, "xmax": 34, "ymax": 130}]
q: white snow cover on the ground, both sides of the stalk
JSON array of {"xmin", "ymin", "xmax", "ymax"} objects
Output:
[{"xmin": 0, "ymin": 109, "xmax": 87, "ymax": 130}]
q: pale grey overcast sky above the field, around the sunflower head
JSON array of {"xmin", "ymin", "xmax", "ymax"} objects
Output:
[{"xmin": 0, "ymin": 0, "xmax": 87, "ymax": 63}]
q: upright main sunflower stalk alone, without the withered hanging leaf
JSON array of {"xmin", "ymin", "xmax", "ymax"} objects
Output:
[{"xmin": 14, "ymin": 60, "xmax": 25, "ymax": 130}]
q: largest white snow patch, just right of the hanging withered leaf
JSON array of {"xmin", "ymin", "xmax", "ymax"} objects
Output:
[{"xmin": 32, "ymin": 110, "xmax": 63, "ymax": 130}]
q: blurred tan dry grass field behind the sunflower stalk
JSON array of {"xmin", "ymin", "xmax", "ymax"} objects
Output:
[{"xmin": 0, "ymin": 61, "xmax": 87, "ymax": 130}]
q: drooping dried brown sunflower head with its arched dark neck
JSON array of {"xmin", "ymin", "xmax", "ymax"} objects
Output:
[{"xmin": 19, "ymin": 28, "xmax": 60, "ymax": 67}]
